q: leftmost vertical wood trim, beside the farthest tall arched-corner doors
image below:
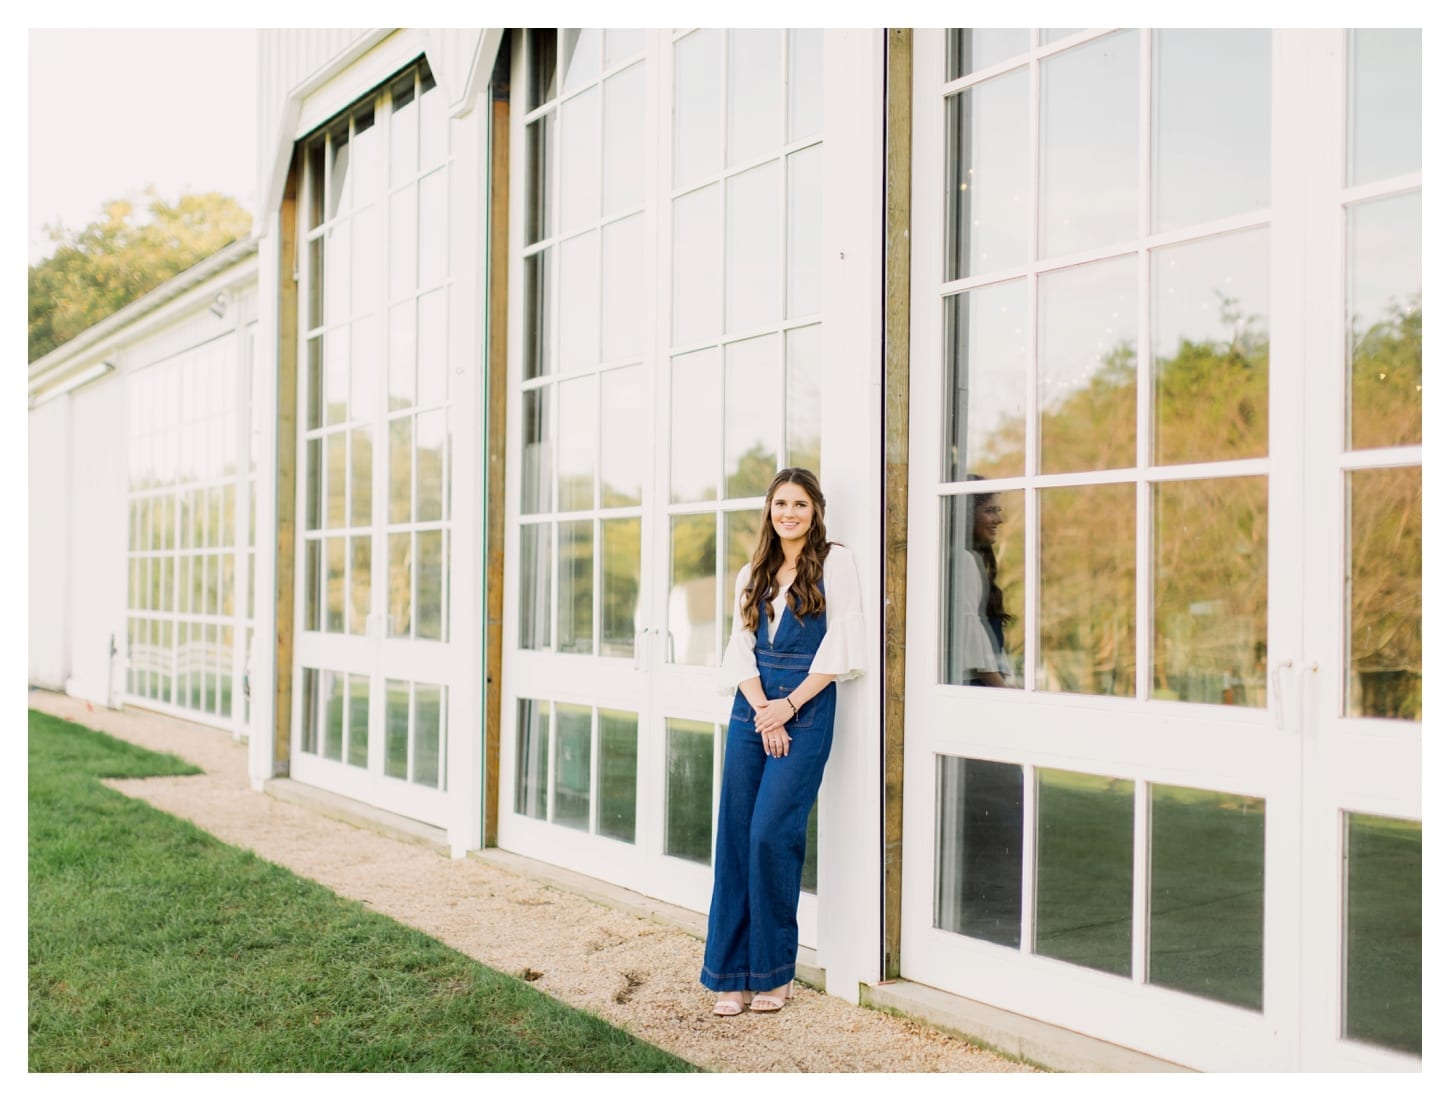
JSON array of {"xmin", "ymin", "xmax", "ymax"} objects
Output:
[{"xmin": 271, "ymin": 151, "xmax": 302, "ymax": 776}]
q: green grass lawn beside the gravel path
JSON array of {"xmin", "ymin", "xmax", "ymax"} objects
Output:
[{"xmin": 29, "ymin": 711, "xmax": 696, "ymax": 1072}]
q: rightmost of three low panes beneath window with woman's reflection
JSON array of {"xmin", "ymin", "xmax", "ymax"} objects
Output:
[{"xmin": 1148, "ymin": 783, "xmax": 1264, "ymax": 1010}]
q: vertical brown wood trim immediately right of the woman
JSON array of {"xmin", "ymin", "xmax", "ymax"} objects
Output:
[{"xmin": 882, "ymin": 28, "xmax": 912, "ymax": 979}]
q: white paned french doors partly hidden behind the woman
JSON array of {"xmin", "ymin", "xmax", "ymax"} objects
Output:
[{"xmin": 499, "ymin": 29, "xmax": 824, "ymax": 943}]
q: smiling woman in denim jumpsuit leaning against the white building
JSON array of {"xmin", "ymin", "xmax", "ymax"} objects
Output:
[{"xmin": 700, "ymin": 467, "xmax": 866, "ymax": 1017}]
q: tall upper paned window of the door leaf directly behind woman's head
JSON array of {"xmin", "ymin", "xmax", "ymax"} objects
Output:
[{"xmin": 666, "ymin": 30, "xmax": 824, "ymax": 666}]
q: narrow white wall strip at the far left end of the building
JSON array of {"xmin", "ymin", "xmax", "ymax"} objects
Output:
[{"xmin": 26, "ymin": 396, "xmax": 71, "ymax": 690}]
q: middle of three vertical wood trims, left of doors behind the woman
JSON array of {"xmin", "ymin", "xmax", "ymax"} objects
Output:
[{"xmin": 483, "ymin": 41, "xmax": 512, "ymax": 847}]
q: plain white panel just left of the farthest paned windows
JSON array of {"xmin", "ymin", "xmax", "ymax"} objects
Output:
[{"xmin": 65, "ymin": 376, "xmax": 128, "ymax": 705}]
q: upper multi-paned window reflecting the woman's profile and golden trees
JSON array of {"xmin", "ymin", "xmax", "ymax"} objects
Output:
[{"xmin": 938, "ymin": 30, "xmax": 1270, "ymax": 706}]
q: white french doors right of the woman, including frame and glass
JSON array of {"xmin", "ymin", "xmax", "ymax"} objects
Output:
[{"xmin": 902, "ymin": 30, "xmax": 1420, "ymax": 1069}]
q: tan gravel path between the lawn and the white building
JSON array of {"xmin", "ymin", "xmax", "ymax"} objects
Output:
[{"xmin": 29, "ymin": 690, "xmax": 1031, "ymax": 1072}]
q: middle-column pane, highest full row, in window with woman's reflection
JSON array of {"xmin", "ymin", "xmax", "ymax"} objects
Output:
[{"xmin": 1038, "ymin": 30, "xmax": 1138, "ymax": 257}]
